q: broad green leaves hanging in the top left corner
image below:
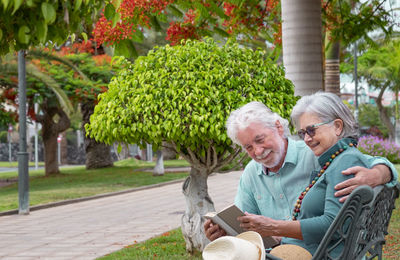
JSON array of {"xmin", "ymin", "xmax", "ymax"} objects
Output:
[{"xmin": 0, "ymin": 0, "xmax": 103, "ymax": 54}]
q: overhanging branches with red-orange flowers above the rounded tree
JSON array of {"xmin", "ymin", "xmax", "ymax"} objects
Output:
[{"xmin": 93, "ymin": 0, "xmax": 281, "ymax": 57}]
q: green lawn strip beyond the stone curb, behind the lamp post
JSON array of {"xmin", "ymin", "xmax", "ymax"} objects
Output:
[{"xmin": 0, "ymin": 159, "xmax": 187, "ymax": 212}]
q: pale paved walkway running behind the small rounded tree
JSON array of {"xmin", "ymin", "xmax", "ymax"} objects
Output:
[{"xmin": 0, "ymin": 171, "xmax": 241, "ymax": 260}]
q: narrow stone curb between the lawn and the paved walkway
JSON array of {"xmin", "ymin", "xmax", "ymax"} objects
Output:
[{"xmin": 0, "ymin": 179, "xmax": 185, "ymax": 216}]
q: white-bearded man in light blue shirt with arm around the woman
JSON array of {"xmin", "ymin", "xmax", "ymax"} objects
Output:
[{"xmin": 204, "ymin": 102, "xmax": 398, "ymax": 241}]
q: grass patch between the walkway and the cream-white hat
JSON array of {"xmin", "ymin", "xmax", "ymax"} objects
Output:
[{"xmin": 98, "ymin": 228, "xmax": 202, "ymax": 260}]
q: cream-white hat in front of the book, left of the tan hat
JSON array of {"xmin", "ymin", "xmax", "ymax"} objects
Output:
[{"xmin": 203, "ymin": 231, "xmax": 265, "ymax": 260}]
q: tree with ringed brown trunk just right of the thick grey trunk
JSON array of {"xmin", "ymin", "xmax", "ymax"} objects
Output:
[{"xmin": 322, "ymin": 0, "xmax": 397, "ymax": 95}]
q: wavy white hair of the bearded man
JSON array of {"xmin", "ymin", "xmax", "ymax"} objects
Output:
[{"xmin": 226, "ymin": 101, "xmax": 289, "ymax": 145}]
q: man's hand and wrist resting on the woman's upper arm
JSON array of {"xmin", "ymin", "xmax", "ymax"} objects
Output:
[{"xmin": 335, "ymin": 164, "xmax": 391, "ymax": 202}]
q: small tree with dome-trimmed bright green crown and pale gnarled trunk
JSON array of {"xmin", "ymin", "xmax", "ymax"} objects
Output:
[{"xmin": 86, "ymin": 39, "xmax": 296, "ymax": 251}]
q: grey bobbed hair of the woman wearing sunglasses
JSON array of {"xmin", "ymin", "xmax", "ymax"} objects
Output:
[{"xmin": 291, "ymin": 92, "xmax": 359, "ymax": 139}]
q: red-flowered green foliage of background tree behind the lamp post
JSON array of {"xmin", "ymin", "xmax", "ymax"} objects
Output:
[{"xmin": 0, "ymin": 41, "xmax": 114, "ymax": 120}]
